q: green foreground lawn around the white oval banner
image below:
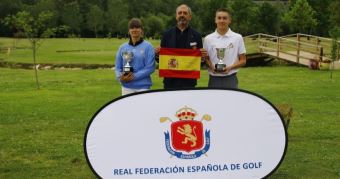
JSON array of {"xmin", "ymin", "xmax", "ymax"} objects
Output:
[{"xmin": 0, "ymin": 67, "xmax": 340, "ymax": 178}]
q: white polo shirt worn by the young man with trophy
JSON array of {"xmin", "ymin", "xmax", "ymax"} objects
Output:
[{"xmin": 203, "ymin": 28, "xmax": 246, "ymax": 76}]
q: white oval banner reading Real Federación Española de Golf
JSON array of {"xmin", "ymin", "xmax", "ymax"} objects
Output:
[{"xmin": 84, "ymin": 88, "xmax": 287, "ymax": 179}]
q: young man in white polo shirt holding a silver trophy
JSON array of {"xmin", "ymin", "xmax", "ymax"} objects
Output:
[{"xmin": 203, "ymin": 8, "xmax": 246, "ymax": 88}]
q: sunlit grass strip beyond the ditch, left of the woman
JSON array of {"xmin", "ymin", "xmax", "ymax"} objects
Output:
[{"xmin": 0, "ymin": 38, "xmax": 159, "ymax": 64}]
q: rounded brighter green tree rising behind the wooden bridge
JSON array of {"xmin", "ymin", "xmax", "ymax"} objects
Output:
[{"xmin": 283, "ymin": 0, "xmax": 317, "ymax": 33}]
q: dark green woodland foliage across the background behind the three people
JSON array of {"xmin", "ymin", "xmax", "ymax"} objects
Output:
[{"xmin": 0, "ymin": 0, "xmax": 340, "ymax": 38}]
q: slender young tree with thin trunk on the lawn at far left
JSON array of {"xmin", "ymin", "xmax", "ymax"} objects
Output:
[{"xmin": 5, "ymin": 11, "xmax": 55, "ymax": 89}]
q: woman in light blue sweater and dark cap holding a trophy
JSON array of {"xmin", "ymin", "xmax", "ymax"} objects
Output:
[{"xmin": 115, "ymin": 18, "xmax": 155, "ymax": 95}]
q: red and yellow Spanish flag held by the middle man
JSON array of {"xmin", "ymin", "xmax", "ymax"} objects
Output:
[{"xmin": 159, "ymin": 48, "xmax": 201, "ymax": 79}]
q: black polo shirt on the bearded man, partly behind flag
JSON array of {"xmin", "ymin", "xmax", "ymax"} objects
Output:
[{"xmin": 161, "ymin": 27, "xmax": 203, "ymax": 89}]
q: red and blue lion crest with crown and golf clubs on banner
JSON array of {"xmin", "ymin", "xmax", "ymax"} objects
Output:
[{"xmin": 160, "ymin": 106, "xmax": 211, "ymax": 159}]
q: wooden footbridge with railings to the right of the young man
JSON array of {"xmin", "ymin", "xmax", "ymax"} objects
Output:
[{"xmin": 244, "ymin": 33, "xmax": 340, "ymax": 69}]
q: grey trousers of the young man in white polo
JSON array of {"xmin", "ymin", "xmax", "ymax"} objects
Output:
[{"xmin": 208, "ymin": 73, "xmax": 238, "ymax": 89}]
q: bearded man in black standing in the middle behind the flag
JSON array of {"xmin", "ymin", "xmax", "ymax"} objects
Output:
[{"xmin": 155, "ymin": 4, "xmax": 207, "ymax": 89}]
